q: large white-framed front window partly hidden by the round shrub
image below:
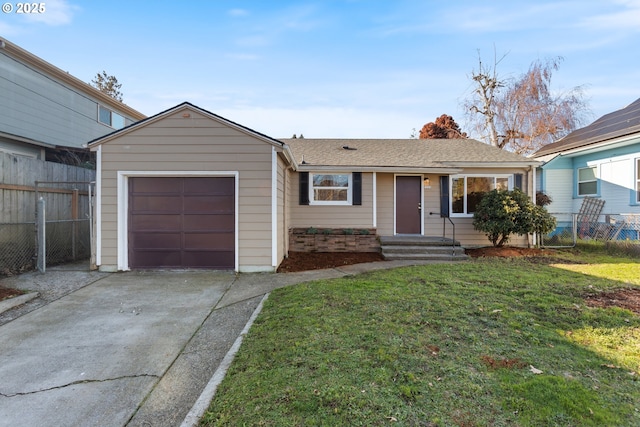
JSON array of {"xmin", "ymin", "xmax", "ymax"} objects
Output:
[{"xmin": 451, "ymin": 175, "xmax": 513, "ymax": 215}]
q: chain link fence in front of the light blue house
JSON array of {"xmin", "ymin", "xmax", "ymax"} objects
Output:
[{"xmin": 540, "ymin": 212, "xmax": 640, "ymax": 248}]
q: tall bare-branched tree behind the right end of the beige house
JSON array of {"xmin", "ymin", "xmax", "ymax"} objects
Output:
[{"xmin": 465, "ymin": 52, "xmax": 588, "ymax": 155}]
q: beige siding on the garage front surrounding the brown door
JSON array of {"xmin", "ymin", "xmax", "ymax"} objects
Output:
[{"xmin": 101, "ymin": 110, "xmax": 272, "ymax": 269}]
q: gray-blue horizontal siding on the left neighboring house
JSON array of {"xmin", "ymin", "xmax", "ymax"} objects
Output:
[{"xmin": 0, "ymin": 51, "xmax": 139, "ymax": 147}]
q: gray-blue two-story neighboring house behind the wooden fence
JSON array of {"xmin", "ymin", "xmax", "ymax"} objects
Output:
[{"xmin": 0, "ymin": 38, "xmax": 145, "ymax": 161}]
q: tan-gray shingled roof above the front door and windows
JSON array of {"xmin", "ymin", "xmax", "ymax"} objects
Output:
[{"xmin": 280, "ymin": 138, "xmax": 535, "ymax": 168}]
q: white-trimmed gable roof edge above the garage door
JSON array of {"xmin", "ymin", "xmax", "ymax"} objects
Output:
[{"xmin": 88, "ymin": 102, "xmax": 284, "ymax": 148}]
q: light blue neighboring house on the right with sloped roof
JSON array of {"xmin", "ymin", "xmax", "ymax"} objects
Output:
[{"xmin": 533, "ymin": 99, "xmax": 640, "ymax": 222}]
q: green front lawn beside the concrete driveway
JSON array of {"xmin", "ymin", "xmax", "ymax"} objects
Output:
[{"xmin": 202, "ymin": 250, "xmax": 640, "ymax": 427}]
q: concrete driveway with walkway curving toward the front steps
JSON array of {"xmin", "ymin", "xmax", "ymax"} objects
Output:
[{"xmin": 0, "ymin": 261, "xmax": 432, "ymax": 427}]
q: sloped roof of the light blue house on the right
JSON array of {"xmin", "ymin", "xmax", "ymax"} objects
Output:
[{"xmin": 533, "ymin": 99, "xmax": 640, "ymax": 158}]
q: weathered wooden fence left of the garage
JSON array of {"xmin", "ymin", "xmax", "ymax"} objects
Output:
[{"xmin": 0, "ymin": 153, "xmax": 95, "ymax": 275}]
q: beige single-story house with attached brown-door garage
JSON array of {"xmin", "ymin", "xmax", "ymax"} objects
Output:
[{"xmin": 89, "ymin": 103, "xmax": 539, "ymax": 271}]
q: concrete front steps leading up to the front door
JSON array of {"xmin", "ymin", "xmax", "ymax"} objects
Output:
[{"xmin": 380, "ymin": 235, "xmax": 469, "ymax": 261}]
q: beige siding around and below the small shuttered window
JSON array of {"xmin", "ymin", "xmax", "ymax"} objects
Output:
[{"xmin": 289, "ymin": 173, "xmax": 373, "ymax": 228}]
